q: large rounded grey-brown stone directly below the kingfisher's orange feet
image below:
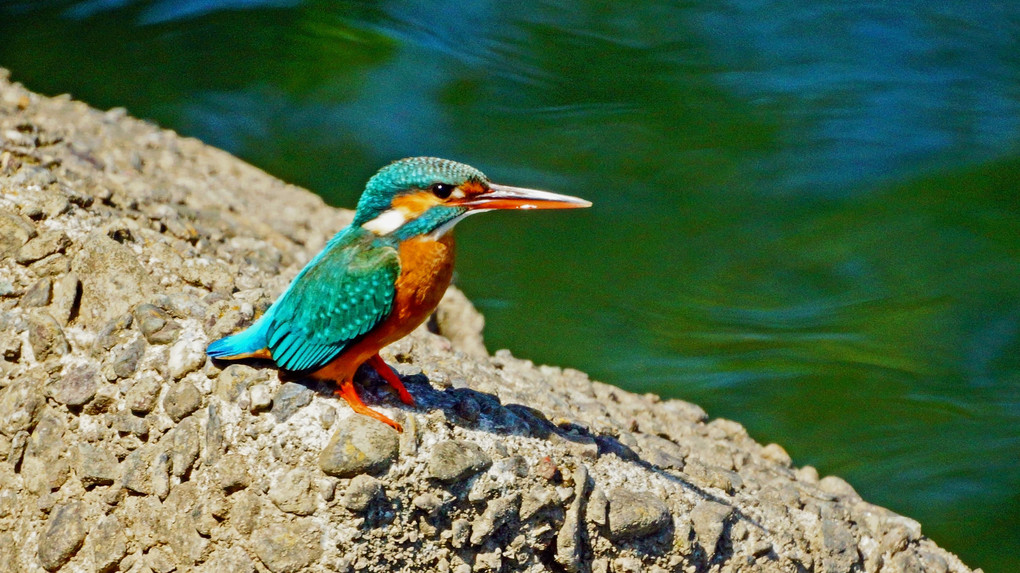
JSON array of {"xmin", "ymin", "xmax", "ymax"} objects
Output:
[{"xmin": 319, "ymin": 415, "xmax": 400, "ymax": 477}]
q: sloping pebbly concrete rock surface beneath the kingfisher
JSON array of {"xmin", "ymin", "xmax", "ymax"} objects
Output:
[{"xmin": 0, "ymin": 70, "xmax": 969, "ymax": 572}]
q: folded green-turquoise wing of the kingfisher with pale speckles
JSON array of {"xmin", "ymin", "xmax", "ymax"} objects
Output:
[{"xmin": 266, "ymin": 229, "xmax": 400, "ymax": 372}]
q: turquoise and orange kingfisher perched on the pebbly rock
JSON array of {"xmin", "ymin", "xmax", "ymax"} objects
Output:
[{"xmin": 206, "ymin": 157, "xmax": 592, "ymax": 431}]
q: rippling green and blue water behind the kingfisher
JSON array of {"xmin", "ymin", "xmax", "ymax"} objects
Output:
[{"xmin": 0, "ymin": 0, "xmax": 1020, "ymax": 573}]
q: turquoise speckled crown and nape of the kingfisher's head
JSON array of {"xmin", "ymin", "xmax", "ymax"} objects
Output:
[{"xmin": 354, "ymin": 157, "xmax": 489, "ymax": 225}]
